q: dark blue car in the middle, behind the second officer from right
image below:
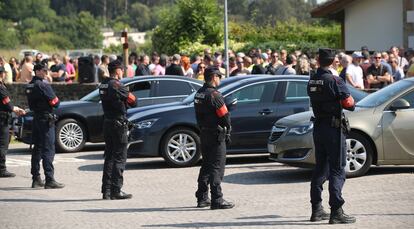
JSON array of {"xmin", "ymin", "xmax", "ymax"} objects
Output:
[{"xmin": 128, "ymin": 75, "xmax": 309, "ymax": 167}]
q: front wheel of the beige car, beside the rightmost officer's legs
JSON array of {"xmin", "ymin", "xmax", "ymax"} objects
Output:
[{"xmin": 345, "ymin": 132, "xmax": 373, "ymax": 177}]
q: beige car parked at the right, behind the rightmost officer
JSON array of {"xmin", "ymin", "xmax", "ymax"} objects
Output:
[{"xmin": 268, "ymin": 78, "xmax": 414, "ymax": 177}]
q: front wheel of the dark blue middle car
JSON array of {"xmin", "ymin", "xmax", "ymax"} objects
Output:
[{"xmin": 161, "ymin": 128, "xmax": 201, "ymax": 167}]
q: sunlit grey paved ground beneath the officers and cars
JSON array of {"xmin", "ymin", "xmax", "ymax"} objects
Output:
[{"xmin": 0, "ymin": 144, "xmax": 414, "ymax": 228}]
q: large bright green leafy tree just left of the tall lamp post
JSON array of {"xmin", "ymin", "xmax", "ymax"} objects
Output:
[{"xmin": 152, "ymin": 0, "xmax": 223, "ymax": 54}]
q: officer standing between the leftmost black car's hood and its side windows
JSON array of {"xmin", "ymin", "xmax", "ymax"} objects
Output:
[{"xmin": 99, "ymin": 60, "xmax": 137, "ymax": 200}]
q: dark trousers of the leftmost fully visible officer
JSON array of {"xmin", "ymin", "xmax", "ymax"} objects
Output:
[{"xmin": 31, "ymin": 114, "xmax": 55, "ymax": 182}]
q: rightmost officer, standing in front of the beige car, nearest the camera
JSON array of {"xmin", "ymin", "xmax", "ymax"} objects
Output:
[{"xmin": 308, "ymin": 49, "xmax": 356, "ymax": 224}]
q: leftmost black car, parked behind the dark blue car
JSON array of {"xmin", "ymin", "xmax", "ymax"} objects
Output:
[{"xmin": 15, "ymin": 76, "xmax": 203, "ymax": 152}]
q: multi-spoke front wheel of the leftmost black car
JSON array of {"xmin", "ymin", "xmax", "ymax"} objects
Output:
[{"xmin": 56, "ymin": 119, "xmax": 86, "ymax": 153}]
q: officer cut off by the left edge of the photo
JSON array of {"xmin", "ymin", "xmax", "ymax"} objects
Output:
[{"xmin": 0, "ymin": 66, "xmax": 25, "ymax": 178}]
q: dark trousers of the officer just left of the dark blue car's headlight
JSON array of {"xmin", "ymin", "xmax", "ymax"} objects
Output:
[{"xmin": 102, "ymin": 119, "xmax": 128, "ymax": 193}]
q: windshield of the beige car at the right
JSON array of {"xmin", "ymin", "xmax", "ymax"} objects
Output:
[{"xmin": 356, "ymin": 80, "xmax": 413, "ymax": 107}]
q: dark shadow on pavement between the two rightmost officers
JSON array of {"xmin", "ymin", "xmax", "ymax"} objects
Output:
[{"xmin": 224, "ymin": 169, "xmax": 312, "ymax": 185}]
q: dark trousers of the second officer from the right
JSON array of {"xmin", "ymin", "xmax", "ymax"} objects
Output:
[{"xmin": 196, "ymin": 130, "xmax": 226, "ymax": 203}]
